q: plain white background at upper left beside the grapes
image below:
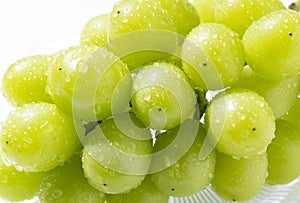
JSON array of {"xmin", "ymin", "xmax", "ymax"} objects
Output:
[{"xmin": 0, "ymin": 0, "xmax": 116, "ymax": 121}]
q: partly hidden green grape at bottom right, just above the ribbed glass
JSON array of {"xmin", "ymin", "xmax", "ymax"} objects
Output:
[{"xmin": 212, "ymin": 153, "xmax": 268, "ymax": 202}]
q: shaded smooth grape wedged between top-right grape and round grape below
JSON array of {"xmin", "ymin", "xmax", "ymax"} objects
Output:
[{"xmin": 233, "ymin": 66, "xmax": 299, "ymax": 118}]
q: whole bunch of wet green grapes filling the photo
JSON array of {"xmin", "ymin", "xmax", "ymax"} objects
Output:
[{"xmin": 0, "ymin": 0, "xmax": 300, "ymax": 203}]
